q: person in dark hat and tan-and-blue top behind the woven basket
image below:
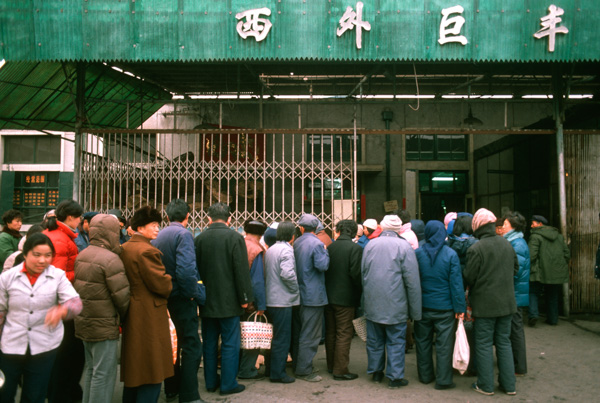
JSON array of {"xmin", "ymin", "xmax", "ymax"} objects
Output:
[{"xmin": 238, "ymin": 219, "xmax": 267, "ymax": 379}]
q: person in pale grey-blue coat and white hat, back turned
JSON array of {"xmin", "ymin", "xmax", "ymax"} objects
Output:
[{"xmin": 361, "ymin": 215, "xmax": 421, "ymax": 389}]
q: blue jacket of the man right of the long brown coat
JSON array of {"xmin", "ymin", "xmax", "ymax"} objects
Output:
[{"xmin": 150, "ymin": 222, "xmax": 206, "ymax": 304}]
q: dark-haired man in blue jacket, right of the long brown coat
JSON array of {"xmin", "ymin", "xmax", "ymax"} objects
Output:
[{"xmin": 152, "ymin": 199, "xmax": 206, "ymax": 402}]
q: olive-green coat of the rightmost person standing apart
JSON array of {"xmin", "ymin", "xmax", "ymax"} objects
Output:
[{"xmin": 529, "ymin": 225, "xmax": 571, "ymax": 284}]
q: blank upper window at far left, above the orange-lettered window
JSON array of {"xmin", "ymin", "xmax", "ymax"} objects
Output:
[{"xmin": 4, "ymin": 136, "xmax": 61, "ymax": 164}]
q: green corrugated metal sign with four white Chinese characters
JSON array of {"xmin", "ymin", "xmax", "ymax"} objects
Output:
[{"xmin": 0, "ymin": 0, "xmax": 600, "ymax": 61}]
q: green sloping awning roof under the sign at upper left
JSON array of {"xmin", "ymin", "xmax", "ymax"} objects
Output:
[{"xmin": 0, "ymin": 62, "xmax": 171, "ymax": 131}]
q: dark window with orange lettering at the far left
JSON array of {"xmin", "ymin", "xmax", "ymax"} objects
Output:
[{"xmin": 13, "ymin": 172, "xmax": 59, "ymax": 224}]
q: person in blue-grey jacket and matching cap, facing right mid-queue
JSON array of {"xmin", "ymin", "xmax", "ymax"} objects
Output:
[{"xmin": 292, "ymin": 214, "xmax": 329, "ymax": 382}]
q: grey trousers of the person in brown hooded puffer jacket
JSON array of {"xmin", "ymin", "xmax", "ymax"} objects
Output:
[{"xmin": 82, "ymin": 339, "xmax": 119, "ymax": 403}]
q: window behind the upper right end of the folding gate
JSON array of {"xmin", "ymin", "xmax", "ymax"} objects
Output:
[{"xmin": 306, "ymin": 134, "xmax": 361, "ymax": 162}]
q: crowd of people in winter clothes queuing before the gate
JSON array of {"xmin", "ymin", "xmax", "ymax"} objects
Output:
[{"xmin": 0, "ymin": 199, "xmax": 570, "ymax": 403}]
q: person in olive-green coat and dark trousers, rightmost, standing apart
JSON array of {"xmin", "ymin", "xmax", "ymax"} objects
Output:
[{"xmin": 529, "ymin": 215, "xmax": 571, "ymax": 327}]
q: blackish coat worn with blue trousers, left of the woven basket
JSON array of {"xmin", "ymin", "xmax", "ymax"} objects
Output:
[{"xmin": 194, "ymin": 222, "xmax": 254, "ymax": 318}]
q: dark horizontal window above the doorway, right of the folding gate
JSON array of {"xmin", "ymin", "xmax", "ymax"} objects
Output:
[{"xmin": 406, "ymin": 134, "xmax": 468, "ymax": 161}]
